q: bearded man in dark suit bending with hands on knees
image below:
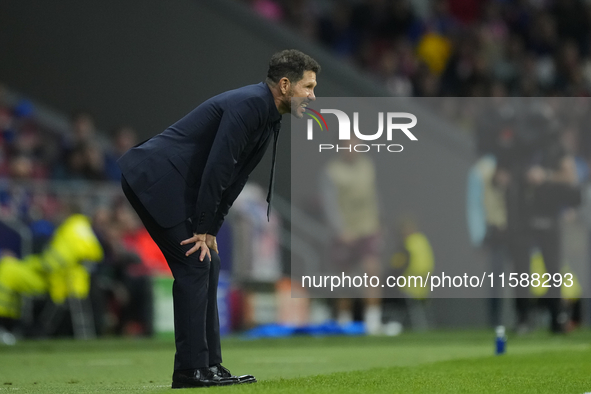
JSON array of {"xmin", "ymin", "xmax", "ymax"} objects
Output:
[{"xmin": 118, "ymin": 50, "xmax": 320, "ymax": 388}]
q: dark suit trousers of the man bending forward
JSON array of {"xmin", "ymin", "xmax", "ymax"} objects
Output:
[{"xmin": 121, "ymin": 177, "xmax": 222, "ymax": 371}]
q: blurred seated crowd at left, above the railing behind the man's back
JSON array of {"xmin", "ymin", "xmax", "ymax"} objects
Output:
[{"xmin": 0, "ymin": 84, "xmax": 137, "ymax": 185}]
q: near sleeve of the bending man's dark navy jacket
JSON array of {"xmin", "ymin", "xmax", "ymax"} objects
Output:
[{"xmin": 192, "ymin": 97, "xmax": 266, "ymax": 234}]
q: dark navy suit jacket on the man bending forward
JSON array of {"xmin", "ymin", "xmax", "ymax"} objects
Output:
[{"xmin": 118, "ymin": 82, "xmax": 281, "ymax": 235}]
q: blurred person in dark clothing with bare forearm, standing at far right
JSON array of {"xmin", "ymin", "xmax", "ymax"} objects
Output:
[{"xmin": 497, "ymin": 99, "xmax": 580, "ymax": 333}]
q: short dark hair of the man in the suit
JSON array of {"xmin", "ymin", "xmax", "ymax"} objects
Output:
[{"xmin": 267, "ymin": 49, "xmax": 320, "ymax": 84}]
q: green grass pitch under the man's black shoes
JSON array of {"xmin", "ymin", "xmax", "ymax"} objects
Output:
[{"xmin": 0, "ymin": 330, "xmax": 591, "ymax": 394}]
